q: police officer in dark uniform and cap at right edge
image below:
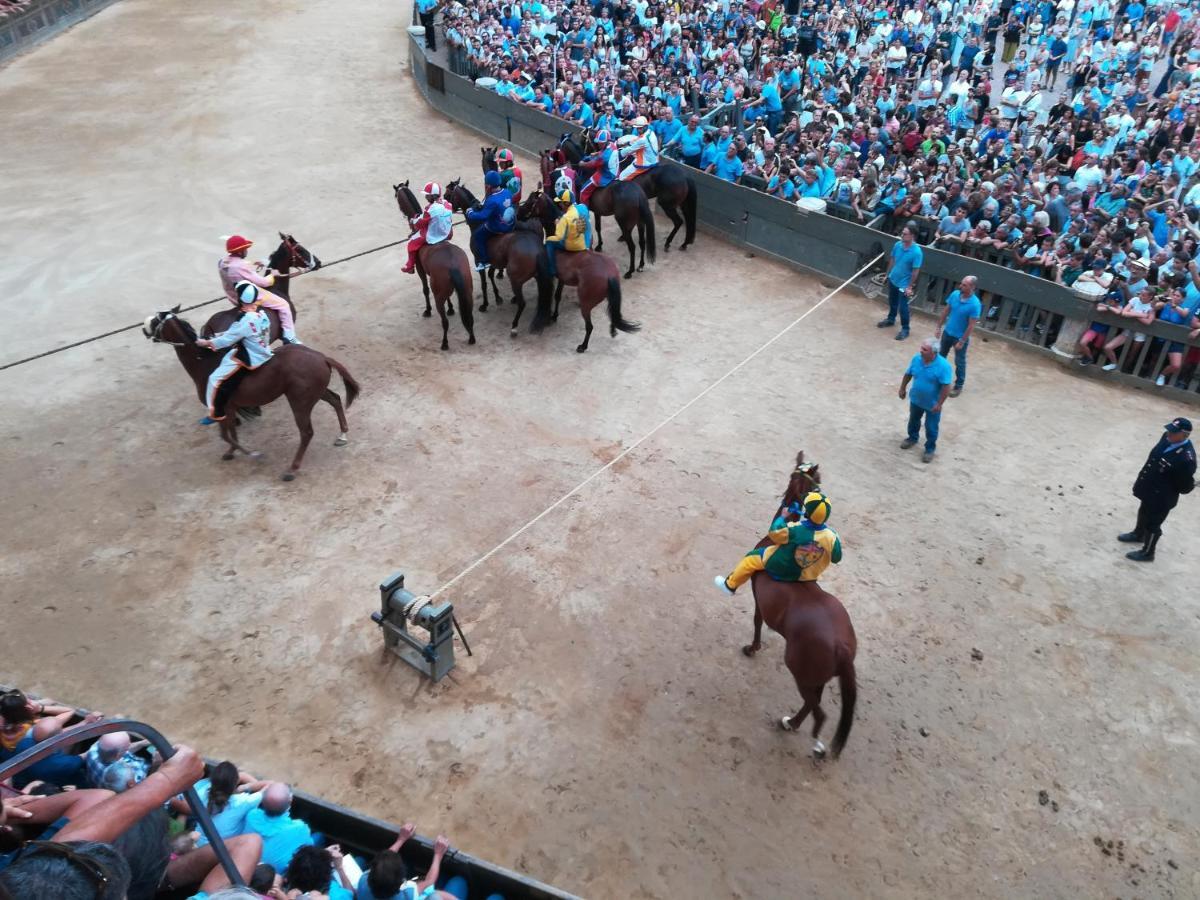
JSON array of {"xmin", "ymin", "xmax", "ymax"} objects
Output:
[{"xmin": 1117, "ymin": 418, "xmax": 1196, "ymax": 563}]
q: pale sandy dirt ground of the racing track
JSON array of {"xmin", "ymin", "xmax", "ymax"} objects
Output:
[{"xmin": 0, "ymin": 0, "xmax": 1200, "ymax": 898}]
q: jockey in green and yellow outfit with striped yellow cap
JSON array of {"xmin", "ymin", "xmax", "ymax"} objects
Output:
[{"xmin": 713, "ymin": 491, "xmax": 841, "ymax": 595}]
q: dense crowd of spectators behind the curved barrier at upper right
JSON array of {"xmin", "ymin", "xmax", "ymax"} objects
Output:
[{"xmin": 443, "ymin": 0, "xmax": 1200, "ymax": 384}]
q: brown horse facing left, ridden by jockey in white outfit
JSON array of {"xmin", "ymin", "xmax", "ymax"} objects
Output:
[{"xmin": 142, "ymin": 306, "xmax": 360, "ymax": 481}]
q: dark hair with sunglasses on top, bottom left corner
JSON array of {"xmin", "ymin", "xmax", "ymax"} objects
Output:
[{"xmin": 0, "ymin": 841, "xmax": 130, "ymax": 900}]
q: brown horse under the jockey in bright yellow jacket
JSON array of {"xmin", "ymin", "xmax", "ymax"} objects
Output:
[{"xmin": 517, "ymin": 188, "xmax": 642, "ymax": 353}]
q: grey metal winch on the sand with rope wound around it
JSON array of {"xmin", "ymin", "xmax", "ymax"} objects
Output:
[{"xmin": 371, "ymin": 572, "xmax": 470, "ymax": 682}]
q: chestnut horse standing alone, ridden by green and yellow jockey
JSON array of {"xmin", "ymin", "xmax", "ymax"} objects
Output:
[{"xmin": 742, "ymin": 451, "xmax": 858, "ymax": 758}]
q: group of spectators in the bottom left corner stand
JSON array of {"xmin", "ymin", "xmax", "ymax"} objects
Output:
[{"xmin": 0, "ymin": 691, "xmax": 503, "ymax": 900}]
